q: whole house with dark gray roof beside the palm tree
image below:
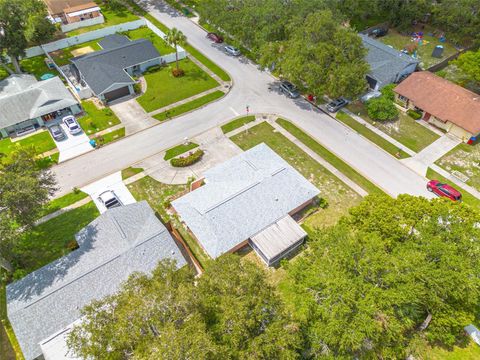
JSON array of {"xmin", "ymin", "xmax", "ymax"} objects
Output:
[{"xmin": 71, "ymin": 34, "xmax": 161, "ymax": 102}]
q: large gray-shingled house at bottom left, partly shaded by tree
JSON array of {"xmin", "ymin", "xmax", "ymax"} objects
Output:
[{"xmin": 7, "ymin": 201, "xmax": 186, "ymax": 360}]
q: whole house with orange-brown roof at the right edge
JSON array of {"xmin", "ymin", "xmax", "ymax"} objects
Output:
[{"xmin": 394, "ymin": 71, "xmax": 480, "ymax": 142}]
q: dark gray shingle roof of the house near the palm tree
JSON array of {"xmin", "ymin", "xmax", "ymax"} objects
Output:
[{"xmin": 71, "ymin": 39, "xmax": 160, "ymax": 95}]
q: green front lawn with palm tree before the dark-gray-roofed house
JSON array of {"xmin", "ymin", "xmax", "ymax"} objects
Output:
[{"xmin": 137, "ymin": 59, "xmax": 218, "ymax": 112}]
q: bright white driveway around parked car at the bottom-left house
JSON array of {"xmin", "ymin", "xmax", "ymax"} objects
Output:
[{"xmin": 80, "ymin": 171, "xmax": 137, "ymax": 214}]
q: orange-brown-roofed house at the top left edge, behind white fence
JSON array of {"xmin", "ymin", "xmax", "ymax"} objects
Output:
[{"xmin": 44, "ymin": 0, "xmax": 105, "ymax": 32}]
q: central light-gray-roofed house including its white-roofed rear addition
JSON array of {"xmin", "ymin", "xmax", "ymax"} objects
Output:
[{"xmin": 172, "ymin": 143, "xmax": 320, "ymax": 265}]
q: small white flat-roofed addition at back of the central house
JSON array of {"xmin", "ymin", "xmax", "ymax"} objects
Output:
[{"xmin": 249, "ymin": 215, "xmax": 307, "ymax": 266}]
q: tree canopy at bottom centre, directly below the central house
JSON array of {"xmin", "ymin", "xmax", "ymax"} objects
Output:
[{"xmin": 68, "ymin": 255, "xmax": 301, "ymax": 359}]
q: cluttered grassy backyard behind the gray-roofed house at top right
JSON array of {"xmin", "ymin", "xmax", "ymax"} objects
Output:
[{"xmin": 378, "ymin": 27, "xmax": 457, "ymax": 70}]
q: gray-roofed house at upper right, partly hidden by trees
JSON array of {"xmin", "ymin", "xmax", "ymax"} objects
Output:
[{"xmin": 359, "ymin": 34, "xmax": 419, "ymax": 90}]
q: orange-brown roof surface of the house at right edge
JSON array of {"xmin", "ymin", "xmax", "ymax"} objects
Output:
[{"xmin": 394, "ymin": 71, "xmax": 480, "ymax": 135}]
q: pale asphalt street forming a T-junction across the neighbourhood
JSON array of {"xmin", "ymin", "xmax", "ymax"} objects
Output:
[{"xmin": 53, "ymin": 0, "xmax": 433, "ymax": 197}]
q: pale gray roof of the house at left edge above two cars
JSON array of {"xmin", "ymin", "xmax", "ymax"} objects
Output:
[{"xmin": 0, "ymin": 75, "xmax": 78, "ymax": 128}]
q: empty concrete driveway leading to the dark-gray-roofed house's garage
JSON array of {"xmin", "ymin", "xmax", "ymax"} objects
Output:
[{"xmin": 110, "ymin": 99, "xmax": 158, "ymax": 135}]
